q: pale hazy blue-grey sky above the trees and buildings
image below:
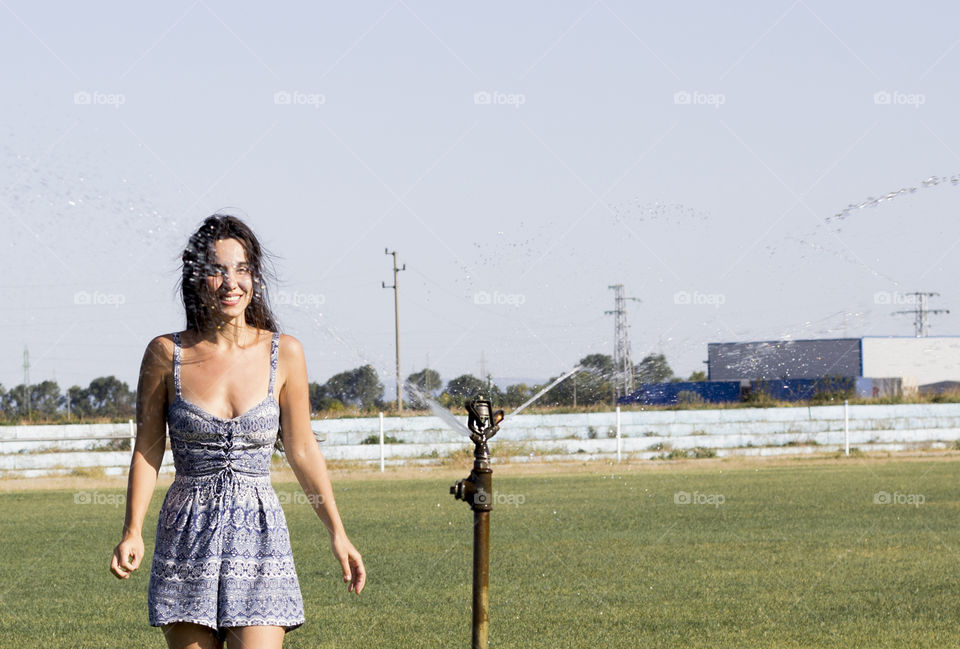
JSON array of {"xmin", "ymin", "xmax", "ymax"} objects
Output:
[{"xmin": 0, "ymin": 0, "xmax": 960, "ymax": 396}]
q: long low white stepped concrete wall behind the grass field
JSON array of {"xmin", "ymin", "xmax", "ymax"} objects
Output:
[{"xmin": 0, "ymin": 404, "xmax": 960, "ymax": 476}]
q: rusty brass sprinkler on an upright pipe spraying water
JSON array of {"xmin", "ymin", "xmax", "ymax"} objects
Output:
[{"xmin": 450, "ymin": 395, "xmax": 503, "ymax": 649}]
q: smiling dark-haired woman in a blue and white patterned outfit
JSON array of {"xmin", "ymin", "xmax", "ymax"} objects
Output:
[{"xmin": 110, "ymin": 214, "xmax": 366, "ymax": 648}]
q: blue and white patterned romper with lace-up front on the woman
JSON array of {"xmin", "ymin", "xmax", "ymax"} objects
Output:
[{"xmin": 147, "ymin": 333, "xmax": 304, "ymax": 638}]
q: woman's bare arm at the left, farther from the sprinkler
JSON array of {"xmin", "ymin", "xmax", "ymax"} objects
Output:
[{"xmin": 110, "ymin": 337, "xmax": 173, "ymax": 579}]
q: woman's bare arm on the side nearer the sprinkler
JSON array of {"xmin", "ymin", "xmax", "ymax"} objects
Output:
[{"xmin": 279, "ymin": 335, "xmax": 367, "ymax": 593}]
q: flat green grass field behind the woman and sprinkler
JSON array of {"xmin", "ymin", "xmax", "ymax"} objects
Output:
[{"xmin": 0, "ymin": 460, "xmax": 960, "ymax": 649}]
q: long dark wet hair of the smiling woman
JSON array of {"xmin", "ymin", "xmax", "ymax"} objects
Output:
[{"xmin": 180, "ymin": 213, "xmax": 280, "ymax": 333}]
